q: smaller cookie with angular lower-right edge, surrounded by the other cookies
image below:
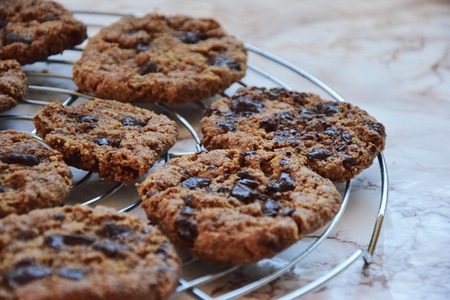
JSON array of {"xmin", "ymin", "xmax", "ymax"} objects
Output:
[{"xmin": 34, "ymin": 99, "xmax": 177, "ymax": 184}]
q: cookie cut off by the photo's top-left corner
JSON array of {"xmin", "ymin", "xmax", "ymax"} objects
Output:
[{"xmin": 0, "ymin": 0, "xmax": 87, "ymax": 65}]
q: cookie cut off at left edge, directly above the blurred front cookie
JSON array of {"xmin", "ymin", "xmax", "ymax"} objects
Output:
[{"xmin": 0, "ymin": 130, "xmax": 72, "ymax": 218}]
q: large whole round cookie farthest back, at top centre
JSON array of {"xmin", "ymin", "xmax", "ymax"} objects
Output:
[{"xmin": 73, "ymin": 13, "xmax": 247, "ymax": 103}]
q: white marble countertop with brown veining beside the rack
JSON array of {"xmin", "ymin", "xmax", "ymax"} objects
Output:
[{"xmin": 47, "ymin": 0, "xmax": 450, "ymax": 299}]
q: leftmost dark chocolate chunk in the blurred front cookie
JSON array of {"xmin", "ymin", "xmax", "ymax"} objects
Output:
[{"xmin": 4, "ymin": 264, "xmax": 53, "ymax": 288}]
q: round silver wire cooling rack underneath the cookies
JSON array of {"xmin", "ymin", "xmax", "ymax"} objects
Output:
[{"xmin": 0, "ymin": 11, "xmax": 388, "ymax": 300}]
